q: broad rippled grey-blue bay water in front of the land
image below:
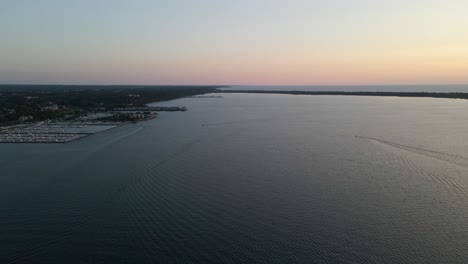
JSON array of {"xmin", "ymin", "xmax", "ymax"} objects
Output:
[{"xmin": 0, "ymin": 94, "xmax": 468, "ymax": 263}]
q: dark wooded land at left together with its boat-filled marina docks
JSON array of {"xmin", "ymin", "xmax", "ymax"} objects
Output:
[{"xmin": 0, "ymin": 85, "xmax": 220, "ymax": 143}]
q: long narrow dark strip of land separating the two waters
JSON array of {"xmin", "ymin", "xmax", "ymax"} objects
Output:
[{"xmin": 217, "ymin": 89, "xmax": 468, "ymax": 100}]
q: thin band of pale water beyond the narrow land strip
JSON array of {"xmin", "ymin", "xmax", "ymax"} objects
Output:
[{"xmin": 225, "ymin": 84, "xmax": 468, "ymax": 93}]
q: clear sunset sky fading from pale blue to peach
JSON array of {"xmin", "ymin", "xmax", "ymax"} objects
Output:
[{"xmin": 0, "ymin": 0, "xmax": 468, "ymax": 85}]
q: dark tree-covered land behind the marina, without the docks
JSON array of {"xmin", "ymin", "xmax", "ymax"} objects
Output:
[{"xmin": 0, "ymin": 85, "xmax": 221, "ymax": 125}]
